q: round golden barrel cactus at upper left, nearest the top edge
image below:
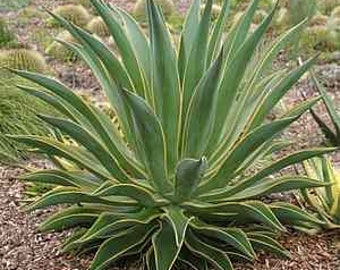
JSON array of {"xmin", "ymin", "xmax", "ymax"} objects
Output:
[{"xmin": 52, "ymin": 5, "xmax": 91, "ymax": 26}]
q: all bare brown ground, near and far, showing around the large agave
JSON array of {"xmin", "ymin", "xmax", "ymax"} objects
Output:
[{"xmin": 0, "ymin": 0, "xmax": 340, "ymax": 270}]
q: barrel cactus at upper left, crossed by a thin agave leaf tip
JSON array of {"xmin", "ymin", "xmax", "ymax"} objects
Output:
[{"xmin": 45, "ymin": 31, "xmax": 77, "ymax": 62}]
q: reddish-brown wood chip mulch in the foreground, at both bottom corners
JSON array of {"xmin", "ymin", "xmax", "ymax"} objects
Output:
[{"xmin": 0, "ymin": 165, "xmax": 340, "ymax": 270}]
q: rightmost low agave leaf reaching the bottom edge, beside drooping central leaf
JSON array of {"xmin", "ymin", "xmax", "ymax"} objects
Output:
[{"xmin": 185, "ymin": 231, "xmax": 233, "ymax": 270}]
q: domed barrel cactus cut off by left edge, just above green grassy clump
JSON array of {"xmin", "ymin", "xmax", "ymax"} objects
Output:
[{"xmin": 0, "ymin": 49, "xmax": 47, "ymax": 73}]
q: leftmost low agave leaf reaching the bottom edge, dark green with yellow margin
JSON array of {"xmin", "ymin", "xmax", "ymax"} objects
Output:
[{"xmin": 90, "ymin": 224, "xmax": 154, "ymax": 270}]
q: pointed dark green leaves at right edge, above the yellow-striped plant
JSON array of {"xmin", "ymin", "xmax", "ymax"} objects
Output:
[{"xmin": 310, "ymin": 73, "xmax": 340, "ymax": 146}]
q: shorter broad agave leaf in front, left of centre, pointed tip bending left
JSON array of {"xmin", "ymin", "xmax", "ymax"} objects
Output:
[{"xmin": 122, "ymin": 91, "xmax": 172, "ymax": 193}]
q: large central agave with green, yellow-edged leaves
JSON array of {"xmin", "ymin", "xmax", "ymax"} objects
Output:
[{"xmin": 9, "ymin": 0, "xmax": 333, "ymax": 270}]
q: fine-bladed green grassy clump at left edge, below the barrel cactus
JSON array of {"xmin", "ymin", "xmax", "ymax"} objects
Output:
[{"xmin": 0, "ymin": 71, "xmax": 52, "ymax": 162}]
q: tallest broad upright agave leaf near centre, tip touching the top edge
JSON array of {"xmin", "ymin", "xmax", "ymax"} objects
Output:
[{"xmin": 148, "ymin": 0, "xmax": 180, "ymax": 171}]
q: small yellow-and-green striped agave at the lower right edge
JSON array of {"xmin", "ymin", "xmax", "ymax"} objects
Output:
[{"xmin": 299, "ymin": 157, "xmax": 340, "ymax": 229}]
